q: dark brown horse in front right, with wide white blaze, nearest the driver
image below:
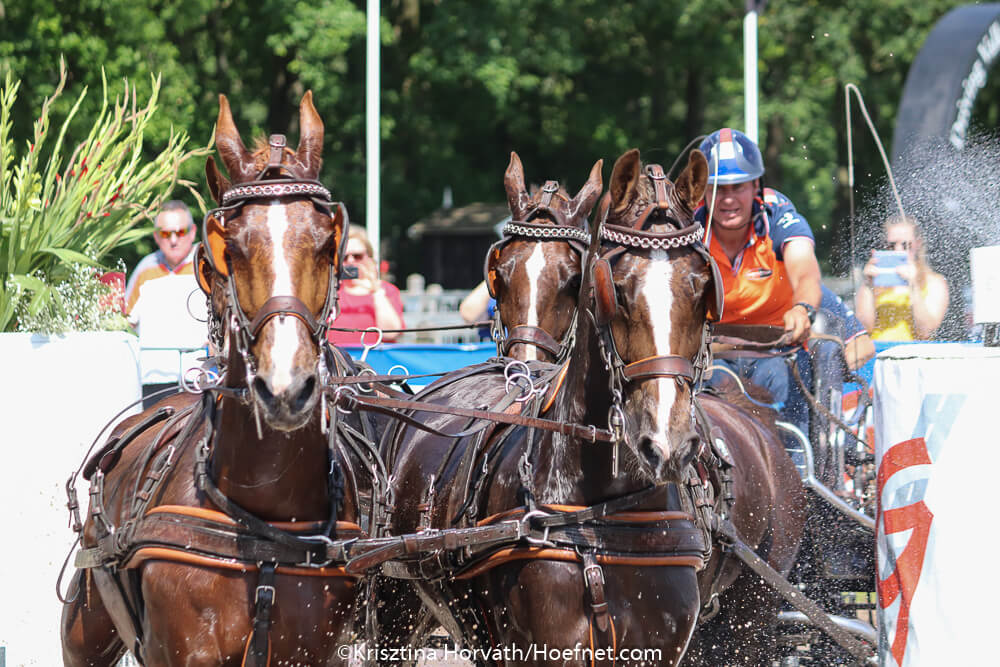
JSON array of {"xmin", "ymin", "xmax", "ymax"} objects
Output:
[{"xmin": 368, "ymin": 149, "xmax": 728, "ymax": 665}]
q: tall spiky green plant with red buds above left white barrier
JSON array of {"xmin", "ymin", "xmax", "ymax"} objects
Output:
[{"xmin": 0, "ymin": 58, "xmax": 209, "ymax": 331}]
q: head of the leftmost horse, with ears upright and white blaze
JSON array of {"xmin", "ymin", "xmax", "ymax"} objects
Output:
[{"xmin": 198, "ymin": 91, "xmax": 347, "ymax": 431}]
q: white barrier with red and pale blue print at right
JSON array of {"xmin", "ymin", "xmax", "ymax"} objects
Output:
[{"xmin": 874, "ymin": 343, "xmax": 1000, "ymax": 667}]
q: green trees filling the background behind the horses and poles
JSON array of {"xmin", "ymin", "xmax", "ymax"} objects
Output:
[{"xmin": 0, "ymin": 0, "xmax": 980, "ymax": 282}]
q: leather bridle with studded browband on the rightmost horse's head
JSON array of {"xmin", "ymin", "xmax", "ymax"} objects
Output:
[{"xmin": 588, "ymin": 164, "xmax": 723, "ymax": 462}]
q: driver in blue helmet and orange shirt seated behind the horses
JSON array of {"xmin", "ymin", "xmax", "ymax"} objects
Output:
[{"xmin": 695, "ymin": 128, "xmax": 821, "ymax": 444}]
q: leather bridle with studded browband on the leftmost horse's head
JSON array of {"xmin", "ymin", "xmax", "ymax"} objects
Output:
[{"xmin": 197, "ymin": 134, "xmax": 348, "ymax": 391}]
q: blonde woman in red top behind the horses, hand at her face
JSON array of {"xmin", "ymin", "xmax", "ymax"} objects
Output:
[{"xmin": 328, "ymin": 225, "xmax": 406, "ymax": 345}]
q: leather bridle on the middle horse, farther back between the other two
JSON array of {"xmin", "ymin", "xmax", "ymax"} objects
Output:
[{"xmin": 483, "ymin": 181, "xmax": 590, "ymax": 363}]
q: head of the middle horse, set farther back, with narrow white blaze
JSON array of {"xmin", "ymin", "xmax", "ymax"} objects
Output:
[{"xmin": 485, "ymin": 153, "xmax": 604, "ymax": 361}]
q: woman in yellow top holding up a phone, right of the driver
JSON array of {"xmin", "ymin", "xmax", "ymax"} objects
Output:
[{"xmin": 854, "ymin": 216, "xmax": 948, "ymax": 341}]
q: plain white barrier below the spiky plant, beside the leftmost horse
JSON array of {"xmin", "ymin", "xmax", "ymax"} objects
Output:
[{"xmin": 0, "ymin": 333, "xmax": 142, "ymax": 667}]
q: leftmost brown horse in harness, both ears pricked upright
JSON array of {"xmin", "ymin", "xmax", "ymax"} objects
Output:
[{"xmin": 62, "ymin": 92, "xmax": 359, "ymax": 666}]
